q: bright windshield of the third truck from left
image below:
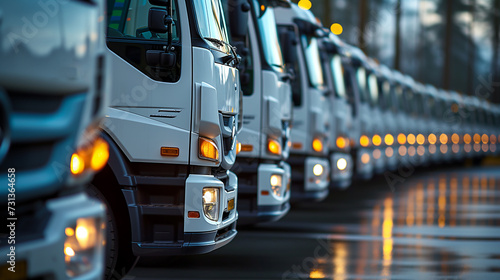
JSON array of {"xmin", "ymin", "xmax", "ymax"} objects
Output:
[{"xmin": 254, "ymin": 0, "xmax": 284, "ymax": 72}]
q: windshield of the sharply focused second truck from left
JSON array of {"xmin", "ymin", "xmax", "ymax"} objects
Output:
[{"xmin": 193, "ymin": 0, "xmax": 231, "ymax": 54}]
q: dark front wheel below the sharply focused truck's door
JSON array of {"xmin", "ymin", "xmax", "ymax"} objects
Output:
[{"xmin": 87, "ymin": 184, "xmax": 138, "ymax": 279}]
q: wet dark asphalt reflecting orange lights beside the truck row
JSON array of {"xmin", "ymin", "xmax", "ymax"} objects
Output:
[{"xmin": 126, "ymin": 166, "xmax": 500, "ymax": 280}]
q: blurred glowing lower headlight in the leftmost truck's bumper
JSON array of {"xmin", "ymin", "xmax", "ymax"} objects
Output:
[{"xmin": 64, "ymin": 217, "xmax": 105, "ymax": 277}]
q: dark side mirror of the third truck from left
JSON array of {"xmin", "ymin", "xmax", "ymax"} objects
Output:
[{"xmin": 227, "ymin": 0, "xmax": 250, "ymax": 38}]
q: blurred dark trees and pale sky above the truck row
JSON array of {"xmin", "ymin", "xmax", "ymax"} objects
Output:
[{"xmin": 292, "ymin": 0, "xmax": 500, "ymax": 103}]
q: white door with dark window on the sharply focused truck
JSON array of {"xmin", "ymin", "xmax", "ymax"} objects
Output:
[{"xmin": 105, "ymin": 0, "xmax": 192, "ymax": 164}]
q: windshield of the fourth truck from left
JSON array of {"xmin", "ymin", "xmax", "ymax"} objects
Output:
[{"xmin": 301, "ymin": 35, "xmax": 325, "ymax": 90}]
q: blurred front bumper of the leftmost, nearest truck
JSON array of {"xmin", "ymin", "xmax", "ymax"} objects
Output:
[{"xmin": 0, "ymin": 193, "xmax": 105, "ymax": 279}]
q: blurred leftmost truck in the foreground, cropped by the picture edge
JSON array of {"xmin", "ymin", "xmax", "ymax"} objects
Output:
[{"xmin": 0, "ymin": 0, "xmax": 108, "ymax": 279}]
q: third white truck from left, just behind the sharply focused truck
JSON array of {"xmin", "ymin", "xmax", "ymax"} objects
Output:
[{"xmin": 223, "ymin": 0, "xmax": 292, "ymax": 225}]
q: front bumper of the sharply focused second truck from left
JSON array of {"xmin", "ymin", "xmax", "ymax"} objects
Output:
[{"xmin": 129, "ymin": 171, "xmax": 238, "ymax": 256}]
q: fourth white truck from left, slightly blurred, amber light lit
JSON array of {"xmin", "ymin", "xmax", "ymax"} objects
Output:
[{"xmin": 275, "ymin": 4, "xmax": 332, "ymax": 201}]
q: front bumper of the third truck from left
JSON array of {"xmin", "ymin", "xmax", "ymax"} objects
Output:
[{"xmin": 238, "ymin": 161, "xmax": 291, "ymax": 225}]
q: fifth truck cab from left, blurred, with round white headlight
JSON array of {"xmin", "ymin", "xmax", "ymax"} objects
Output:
[{"xmin": 320, "ymin": 33, "xmax": 356, "ymax": 189}]
